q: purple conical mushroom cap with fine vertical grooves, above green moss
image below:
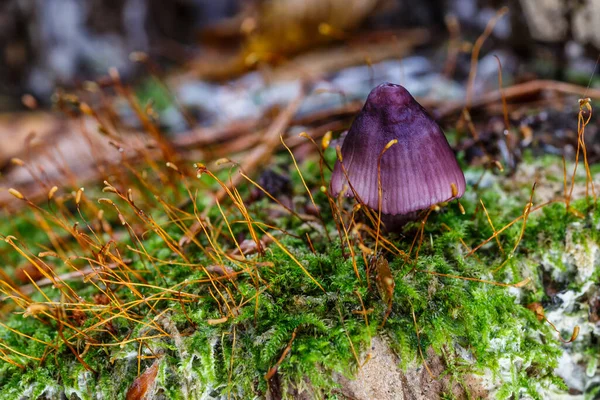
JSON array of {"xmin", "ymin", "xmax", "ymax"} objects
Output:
[{"xmin": 330, "ymin": 83, "xmax": 465, "ymax": 215}]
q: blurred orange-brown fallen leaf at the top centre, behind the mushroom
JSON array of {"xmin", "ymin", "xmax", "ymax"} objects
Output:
[{"xmin": 185, "ymin": 0, "xmax": 381, "ymax": 80}]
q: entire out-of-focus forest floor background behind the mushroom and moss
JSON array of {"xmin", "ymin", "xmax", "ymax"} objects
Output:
[{"xmin": 0, "ymin": 0, "xmax": 600, "ymax": 205}]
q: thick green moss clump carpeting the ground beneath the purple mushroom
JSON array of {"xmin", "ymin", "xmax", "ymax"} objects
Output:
[{"xmin": 0, "ymin": 149, "xmax": 599, "ymax": 399}]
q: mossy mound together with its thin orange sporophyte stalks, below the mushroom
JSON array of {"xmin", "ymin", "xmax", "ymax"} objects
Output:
[{"xmin": 0, "ymin": 83, "xmax": 600, "ymax": 399}]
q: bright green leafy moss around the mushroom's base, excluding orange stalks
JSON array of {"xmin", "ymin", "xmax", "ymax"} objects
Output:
[{"xmin": 0, "ymin": 151, "xmax": 600, "ymax": 399}]
